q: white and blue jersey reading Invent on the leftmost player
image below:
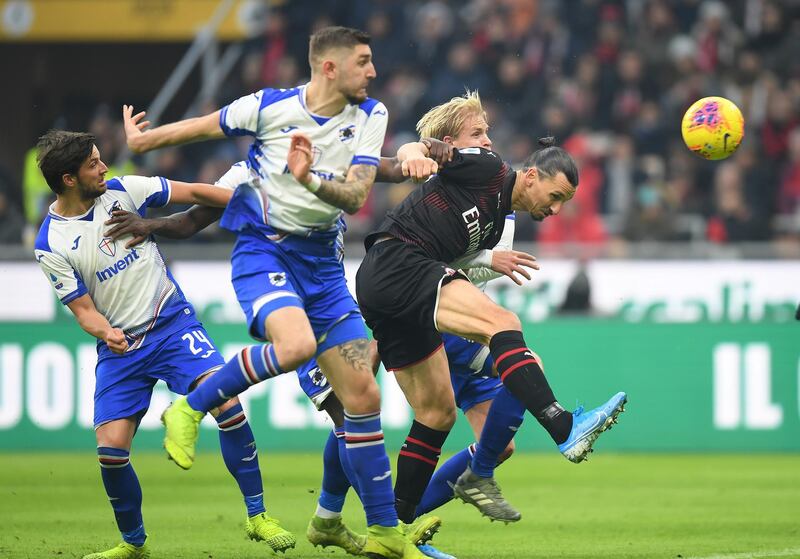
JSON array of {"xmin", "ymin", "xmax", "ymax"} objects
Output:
[{"xmin": 34, "ymin": 176, "xmax": 193, "ymax": 351}]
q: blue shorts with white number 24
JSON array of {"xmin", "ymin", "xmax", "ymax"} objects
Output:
[{"xmin": 94, "ymin": 319, "xmax": 225, "ymax": 429}]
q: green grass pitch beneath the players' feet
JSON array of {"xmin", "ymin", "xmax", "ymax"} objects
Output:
[{"xmin": 0, "ymin": 448, "xmax": 800, "ymax": 559}]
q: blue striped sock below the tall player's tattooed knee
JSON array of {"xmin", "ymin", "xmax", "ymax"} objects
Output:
[{"xmin": 344, "ymin": 410, "xmax": 397, "ymax": 526}]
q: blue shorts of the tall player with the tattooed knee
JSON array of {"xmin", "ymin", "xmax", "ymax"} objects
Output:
[{"xmin": 231, "ymin": 230, "xmax": 367, "ymax": 355}]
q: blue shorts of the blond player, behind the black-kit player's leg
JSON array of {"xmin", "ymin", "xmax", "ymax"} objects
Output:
[{"xmin": 442, "ymin": 334, "xmax": 503, "ymax": 413}]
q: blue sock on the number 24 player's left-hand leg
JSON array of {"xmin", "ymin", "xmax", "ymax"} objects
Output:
[{"xmin": 97, "ymin": 446, "xmax": 146, "ymax": 547}]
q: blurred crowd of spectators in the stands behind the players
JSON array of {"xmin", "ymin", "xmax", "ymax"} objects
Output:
[{"xmin": 6, "ymin": 0, "xmax": 800, "ymax": 250}]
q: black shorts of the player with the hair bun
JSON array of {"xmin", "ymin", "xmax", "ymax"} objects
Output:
[{"xmin": 356, "ymin": 239, "xmax": 469, "ymax": 370}]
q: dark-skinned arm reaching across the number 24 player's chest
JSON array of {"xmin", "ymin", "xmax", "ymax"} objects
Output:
[{"xmin": 105, "ymin": 206, "xmax": 224, "ymax": 248}]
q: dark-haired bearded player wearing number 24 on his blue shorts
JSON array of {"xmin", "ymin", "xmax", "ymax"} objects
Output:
[{"xmin": 34, "ymin": 130, "xmax": 295, "ymax": 559}]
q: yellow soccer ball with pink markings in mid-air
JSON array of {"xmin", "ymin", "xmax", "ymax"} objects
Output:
[{"xmin": 681, "ymin": 97, "xmax": 744, "ymax": 160}]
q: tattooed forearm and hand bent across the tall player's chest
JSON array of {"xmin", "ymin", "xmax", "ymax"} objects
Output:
[{"xmin": 286, "ymin": 133, "xmax": 377, "ymax": 214}]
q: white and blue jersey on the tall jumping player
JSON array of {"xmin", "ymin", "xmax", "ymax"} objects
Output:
[{"xmin": 214, "ymin": 85, "xmax": 388, "ymax": 235}]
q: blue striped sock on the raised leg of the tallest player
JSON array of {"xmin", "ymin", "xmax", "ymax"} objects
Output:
[{"xmin": 186, "ymin": 344, "xmax": 286, "ymax": 412}]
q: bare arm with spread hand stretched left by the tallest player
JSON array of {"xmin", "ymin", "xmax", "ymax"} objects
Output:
[{"xmin": 122, "ymin": 105, "xmax": 225, "ymax": 153}]
